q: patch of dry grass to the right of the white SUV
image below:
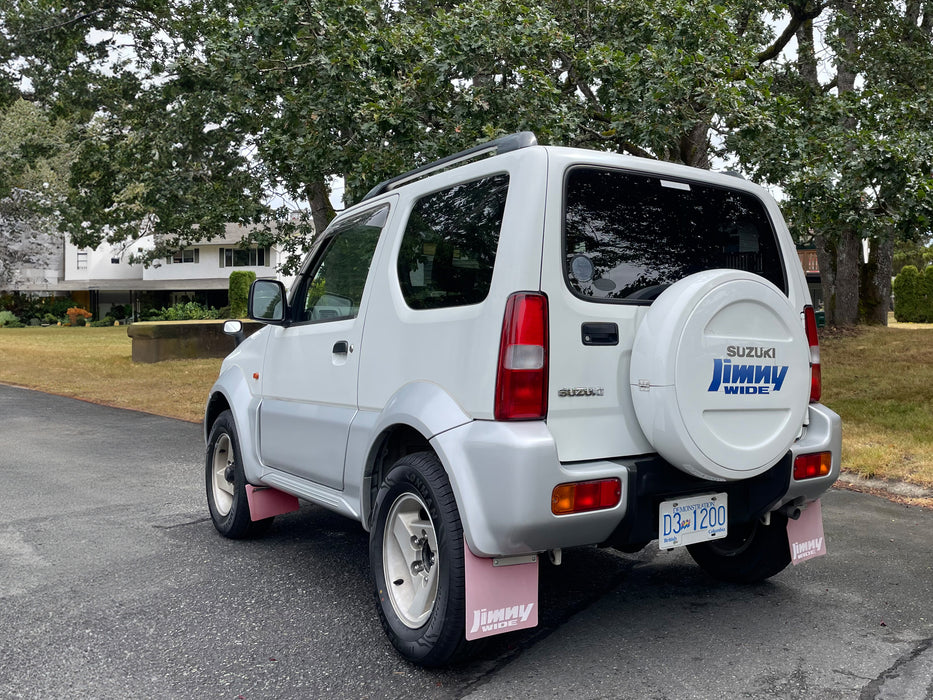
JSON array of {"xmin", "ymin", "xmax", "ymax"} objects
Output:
[{"xmin": 821, "ymin": 319, "xmax": 933, "ymax": 487}]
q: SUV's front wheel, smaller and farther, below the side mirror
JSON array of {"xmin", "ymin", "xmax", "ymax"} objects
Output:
[{"xmin": 204, "ymin": 411, "xmax": 274, "ymax": 540}]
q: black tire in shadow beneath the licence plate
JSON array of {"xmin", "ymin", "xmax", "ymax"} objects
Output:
[{"xmin": 687, "ymin": 513, "xmax": 790, "ymax": 583}]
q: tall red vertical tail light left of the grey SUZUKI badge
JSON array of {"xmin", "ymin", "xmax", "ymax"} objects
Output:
[{"xmin": 494, "ymin": 292, "xmax": 548, "ymax": 420}]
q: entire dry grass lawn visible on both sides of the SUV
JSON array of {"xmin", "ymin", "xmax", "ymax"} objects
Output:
[{"xmin": 0, "ymin": 319, "xmax": 933, "ymax": 488}]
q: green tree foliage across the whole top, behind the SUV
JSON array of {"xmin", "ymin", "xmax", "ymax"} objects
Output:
[{"xmin": 0, "ymin": 0, "xmax": 933, "ymax": 324}]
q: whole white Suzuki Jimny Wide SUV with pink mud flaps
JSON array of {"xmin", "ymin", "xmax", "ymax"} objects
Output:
[{"xmin": 204, "ymin": 132, "xmax": 840, "ymax": 665}]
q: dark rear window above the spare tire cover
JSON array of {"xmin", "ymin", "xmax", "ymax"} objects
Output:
[{"xmin": 564, "ymin": 167, "xmax": 787, "ymax": 303}]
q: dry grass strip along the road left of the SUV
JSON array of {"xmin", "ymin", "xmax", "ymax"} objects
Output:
[{"xmin": 0, "ymin": 326, "xmax": 220, "ymax": 421}]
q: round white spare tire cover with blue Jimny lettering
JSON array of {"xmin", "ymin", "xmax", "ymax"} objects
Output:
[{"xmin": 630, "ymin": 270, "xmax": 810, "ymax": 481}]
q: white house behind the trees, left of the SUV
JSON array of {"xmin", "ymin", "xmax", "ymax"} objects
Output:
[{"xmin": 8, "ymin": 224, "xmax": 290, "ymax": 319}]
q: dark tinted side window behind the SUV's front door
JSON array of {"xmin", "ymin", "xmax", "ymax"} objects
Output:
[{"xmin": 398, "ymin": 174, "xmax": 509, "ymax": 309}]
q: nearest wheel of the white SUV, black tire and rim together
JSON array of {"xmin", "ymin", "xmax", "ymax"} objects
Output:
[{"xmin": 369, "ymin": 452, "xmax": 469, "ymax": 666}]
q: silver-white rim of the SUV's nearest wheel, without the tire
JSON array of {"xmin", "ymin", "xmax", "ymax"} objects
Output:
[{"xmin": 382, "ymin": 493, "xmax": 440, "ymax": 629}]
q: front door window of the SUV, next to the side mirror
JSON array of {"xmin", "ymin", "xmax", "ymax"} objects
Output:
[{"xmin": 295, "ymin": 207, "xmax": 389, "ymax": 322}]
